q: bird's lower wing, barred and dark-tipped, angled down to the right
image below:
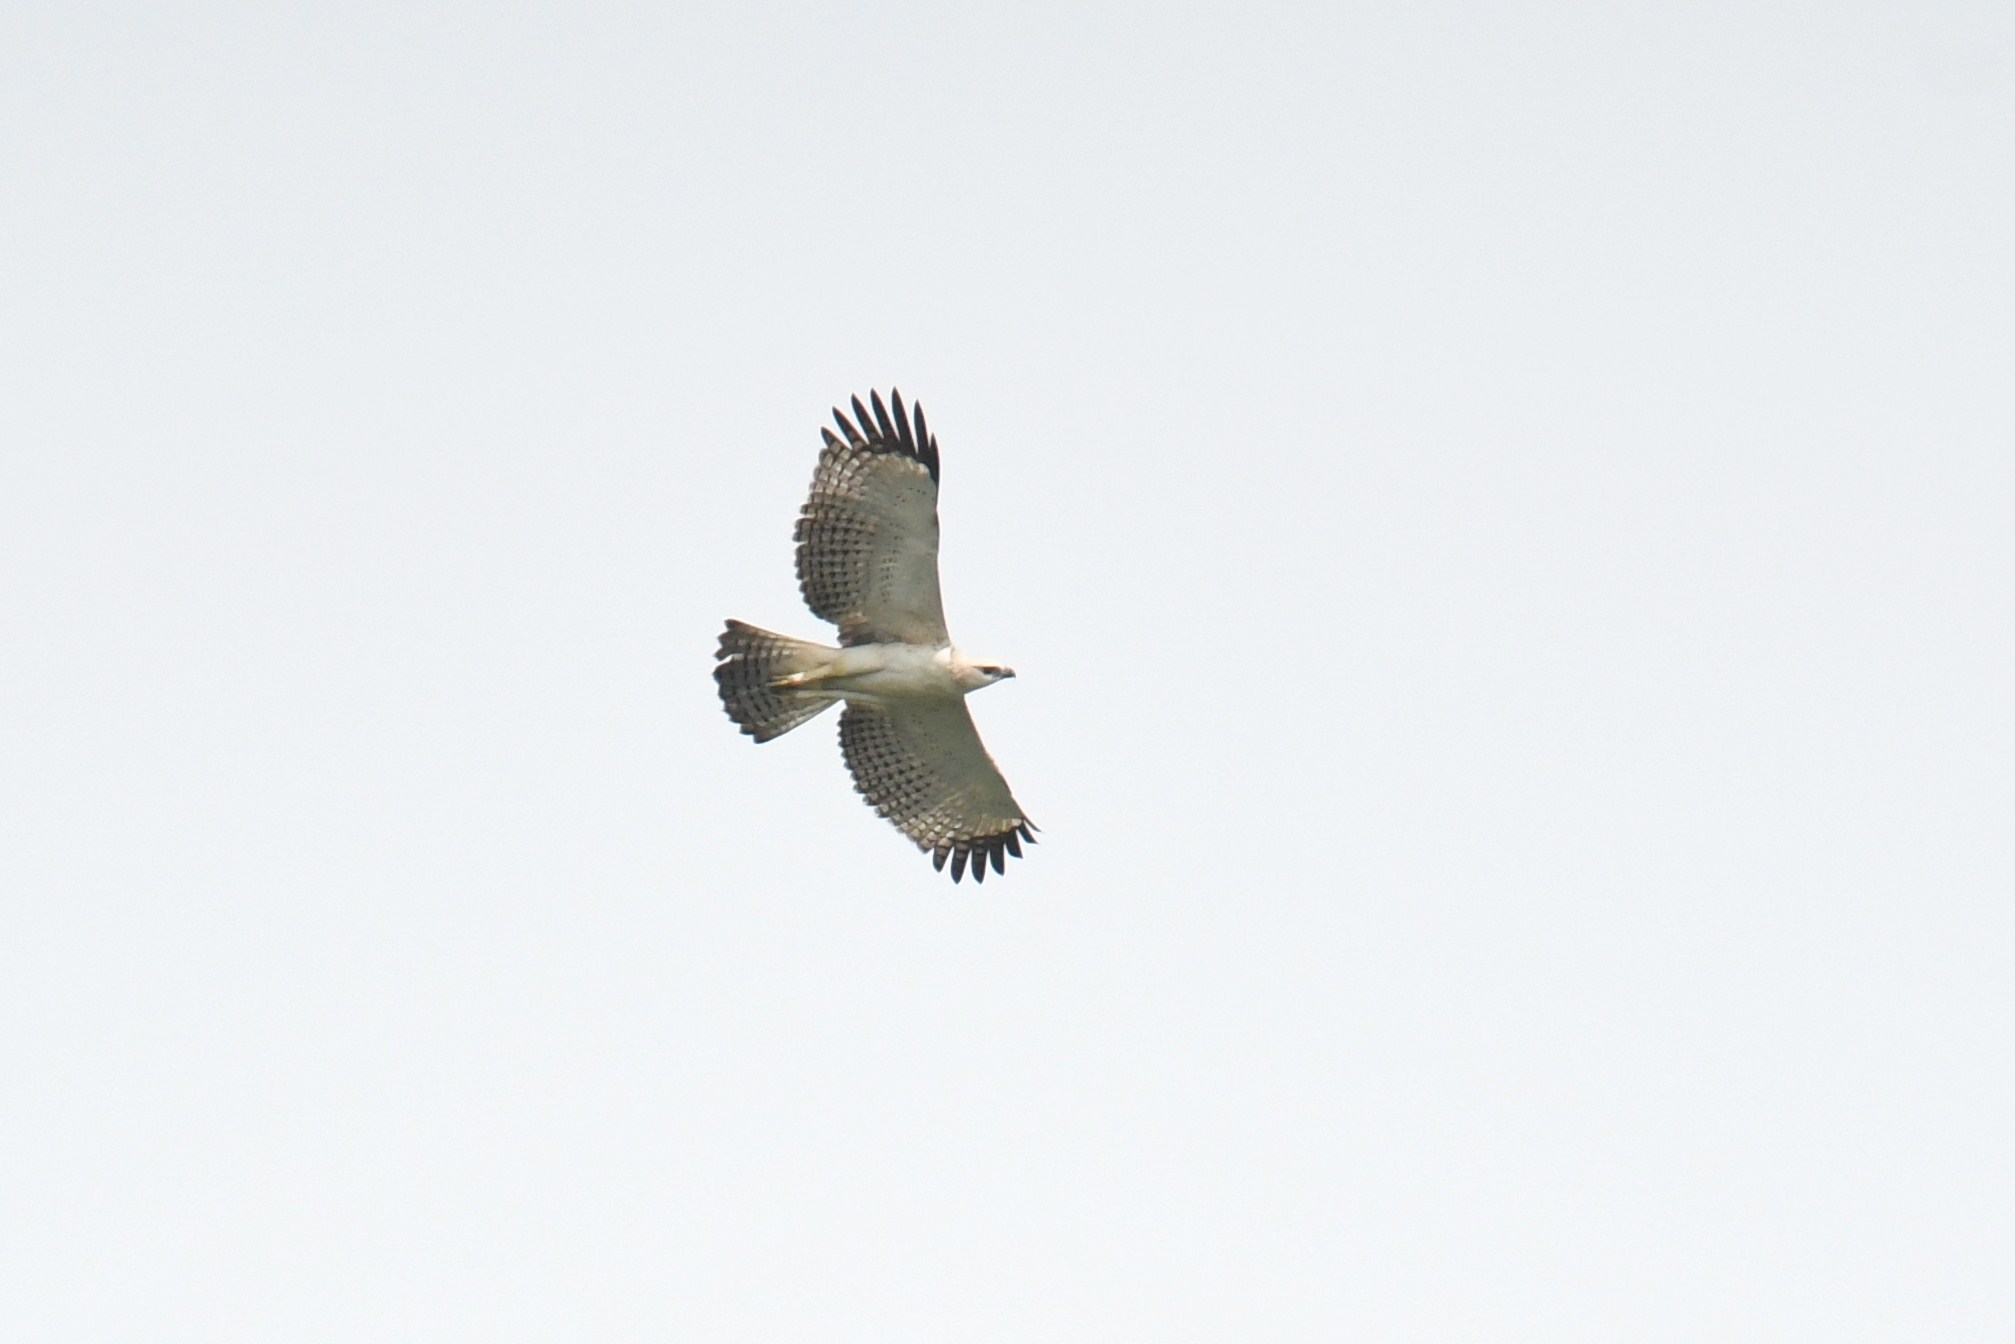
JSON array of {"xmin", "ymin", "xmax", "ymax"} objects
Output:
[{"xmin": 840, "ymin": 699, "xmax": 1036, "ymax": 883}]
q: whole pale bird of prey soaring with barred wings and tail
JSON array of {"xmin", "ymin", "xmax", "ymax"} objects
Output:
[{"xmin": 713, "ymin": 391, "xmax": 1036, "ymax": 883}]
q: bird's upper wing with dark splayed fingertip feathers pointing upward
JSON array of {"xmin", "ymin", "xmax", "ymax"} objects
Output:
[{"xmin": 798, "ymin": 393, "xmax": 949, "ymax": 645}]
